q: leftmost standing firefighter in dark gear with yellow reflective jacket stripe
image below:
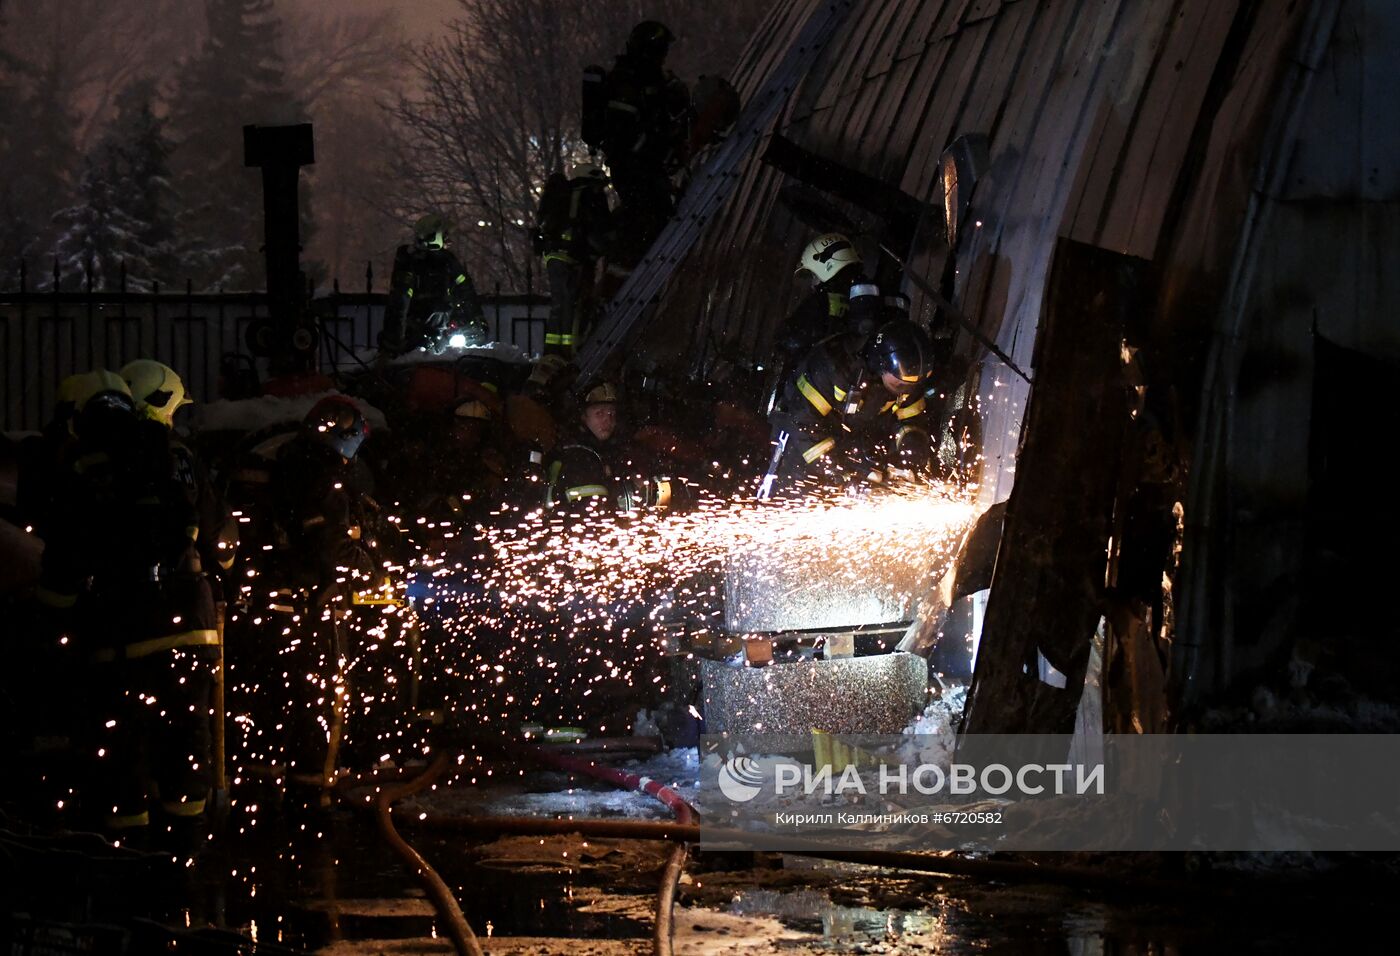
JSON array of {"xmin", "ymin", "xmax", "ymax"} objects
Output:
[{"xmin": 39, "ymin": 371, "xmax": 218, "ymax": 848}]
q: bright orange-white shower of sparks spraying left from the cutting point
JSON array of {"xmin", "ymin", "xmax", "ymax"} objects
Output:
[{"xmin": 207, "ymin": 483, "xmax": 976, "ymax": 827}]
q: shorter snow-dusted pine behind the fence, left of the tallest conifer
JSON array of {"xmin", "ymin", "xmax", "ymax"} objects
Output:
[{"xmin": 55, "ymin": 81, "xmax": 178, "ymax": 291}]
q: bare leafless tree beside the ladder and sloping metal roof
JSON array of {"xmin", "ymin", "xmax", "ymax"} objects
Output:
[{"xmin": 393, "ymin": 0, "xmax": 763, "ymax": 290}]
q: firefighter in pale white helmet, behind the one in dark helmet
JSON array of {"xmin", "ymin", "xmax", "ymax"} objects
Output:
[{"xmin": 762, "ymin": 232, "xmax": 881, "ymax": 414}]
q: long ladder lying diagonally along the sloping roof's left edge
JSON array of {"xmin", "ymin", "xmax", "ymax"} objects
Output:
[{"xmin": 577, "ymin": 0, "xmax": 855, "ymax": 382}]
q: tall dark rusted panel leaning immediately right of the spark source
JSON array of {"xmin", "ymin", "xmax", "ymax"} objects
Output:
[{"xmin": 963, "ymin": 239, "xmax": 1151, "ymax": 733}]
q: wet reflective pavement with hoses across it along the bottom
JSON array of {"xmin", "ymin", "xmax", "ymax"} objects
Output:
[{"xmin": 11, "ymin": 774, "xmax": 1394, "ymax": 956}]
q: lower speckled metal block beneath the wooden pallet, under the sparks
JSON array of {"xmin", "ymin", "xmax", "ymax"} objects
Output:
[{"xmin": 700, "ymin": 654, "xmax": 928, "ymax": 736}]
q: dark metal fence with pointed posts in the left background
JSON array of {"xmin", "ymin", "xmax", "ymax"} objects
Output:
[{"xmin": 0, "ymin": 265, "xmax": 549, "ymax": 431}]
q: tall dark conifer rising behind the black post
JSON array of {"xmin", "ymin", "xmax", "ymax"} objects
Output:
[{"xmin": 169, "ymin": 0, "xmax": 305, "ymax": 290}]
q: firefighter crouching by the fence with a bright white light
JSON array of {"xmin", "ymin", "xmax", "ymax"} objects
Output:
[{"xmin": 379, "ymin": 213, "xmax": 487, "ymax": 356}]
